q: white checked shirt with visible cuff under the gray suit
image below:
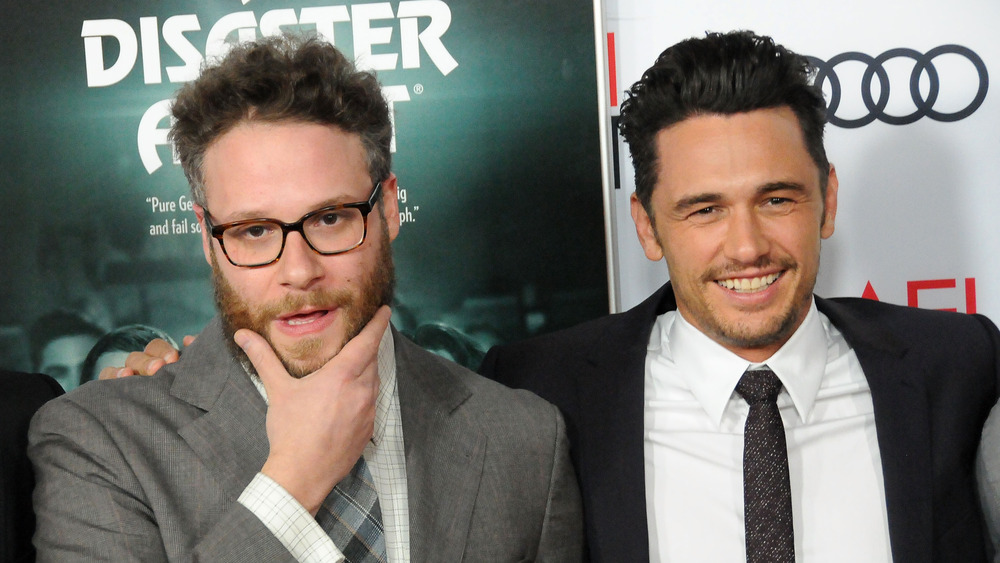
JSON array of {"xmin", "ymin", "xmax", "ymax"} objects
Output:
[{"xmin": 239, "ymin": 327, "xmax": 410, "ymax": 563}]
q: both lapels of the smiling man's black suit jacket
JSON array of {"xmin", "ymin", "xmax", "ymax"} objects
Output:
[{"xmin": 578, "ymin": 283, "xmax": 933, "ymax": 562}]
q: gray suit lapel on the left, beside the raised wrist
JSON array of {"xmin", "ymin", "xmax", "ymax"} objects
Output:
[{"xmin": 171, "ymin": 319, "xmax": 268, "ymax": 499}]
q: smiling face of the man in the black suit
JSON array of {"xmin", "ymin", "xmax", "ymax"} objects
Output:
[{"xmin": 632, "ymin": 107, "xmax": 837, "ymax": 362}]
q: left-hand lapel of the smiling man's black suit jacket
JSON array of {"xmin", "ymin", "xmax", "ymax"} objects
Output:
[{"xmin": 575, "ymin": 284, "xmax": 676, "ymax": 562}]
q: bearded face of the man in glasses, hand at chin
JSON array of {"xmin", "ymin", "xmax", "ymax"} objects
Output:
[{"xmin": 195, "ymin": 122, "xmax": 399, "ymax": 377}]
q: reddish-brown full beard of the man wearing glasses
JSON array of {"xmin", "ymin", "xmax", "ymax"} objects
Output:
[{"xmin": 211, "ymin": 219, "xmax": 396, "ymax": 378}]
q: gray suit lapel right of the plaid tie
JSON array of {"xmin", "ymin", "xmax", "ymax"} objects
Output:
[{"xmin": 393, "ymin": 331, "xmax": 486, "ymax": 562}]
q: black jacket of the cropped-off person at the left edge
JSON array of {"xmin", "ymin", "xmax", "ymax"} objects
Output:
[{"xmin": 0, "ymin": 371, "xmax": 63, "ymax": 563}]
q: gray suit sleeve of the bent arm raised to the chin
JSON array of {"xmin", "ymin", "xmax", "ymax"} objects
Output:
[{"xmin": 28, "ymin": 400, "xmax": 293, "ymax": 562}]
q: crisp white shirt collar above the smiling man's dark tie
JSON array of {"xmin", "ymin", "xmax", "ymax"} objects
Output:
[{"xmin": 657, "ymin": 300, "xmax": 828, "ymax": 425}]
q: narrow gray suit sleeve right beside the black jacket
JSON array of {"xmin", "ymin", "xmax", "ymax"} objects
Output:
[{"xmin": 537, "ymin": 406, "xmax": 583, "ymax": 562}]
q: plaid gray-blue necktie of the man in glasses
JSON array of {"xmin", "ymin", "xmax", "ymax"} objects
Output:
[{"xmin": 316, "ymin": 457, "xmax": 387, "ymax": 563}]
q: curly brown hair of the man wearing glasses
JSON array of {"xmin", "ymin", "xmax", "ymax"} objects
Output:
[{"xmin": 170, "ymin": 35, "xmax": 392, "ymax": 207}]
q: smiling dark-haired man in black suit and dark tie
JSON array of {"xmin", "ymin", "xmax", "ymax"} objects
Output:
[{"xmin": 482, "ymin": 32, "xmax": 1000, "ymax": 563}]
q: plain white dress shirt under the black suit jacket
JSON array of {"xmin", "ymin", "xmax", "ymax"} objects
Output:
[{"xmin": 644, "ymin": 303, "xmax": 892, "ymax": 563}]
